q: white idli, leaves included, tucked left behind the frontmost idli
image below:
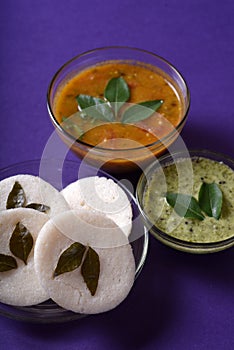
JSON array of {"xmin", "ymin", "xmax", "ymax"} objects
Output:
[{"xmin": 0, "ymin": 208, "xmax": 49, "ymax": 306}]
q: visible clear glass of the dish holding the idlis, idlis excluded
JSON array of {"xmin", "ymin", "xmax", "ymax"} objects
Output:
[{"xmin": 0, "ymin": 159, "xmax": 148, "ymax": 323}]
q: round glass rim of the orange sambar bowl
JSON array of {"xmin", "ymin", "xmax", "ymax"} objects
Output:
[{"xmin": 46, "ymin": 45, "xmax": 191, "ymax": 153}]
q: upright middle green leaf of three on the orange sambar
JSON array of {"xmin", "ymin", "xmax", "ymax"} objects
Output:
[{"xmin": 104, "ymin": 77, "xmax": 130, "ymax": 107}]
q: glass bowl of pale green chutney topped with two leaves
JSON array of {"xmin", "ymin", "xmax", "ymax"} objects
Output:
[{"xmin": 136, "ymin": 150, "xmax": 234, "ymax": 254}]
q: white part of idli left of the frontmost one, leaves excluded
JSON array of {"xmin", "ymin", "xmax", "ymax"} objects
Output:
[{"xmin": 0, "ymin": 208, "xmax": 49, "ymax": 306}]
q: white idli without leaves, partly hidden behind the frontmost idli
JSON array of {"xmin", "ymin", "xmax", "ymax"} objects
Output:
[{"xmin": 61, "ymin": 176, "xmax": 132, "ymax": 236}]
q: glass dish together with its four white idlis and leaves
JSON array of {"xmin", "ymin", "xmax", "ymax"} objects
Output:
[{"xmin": 0, "ymin": 159, "xmax": 148, "ymax": 323}]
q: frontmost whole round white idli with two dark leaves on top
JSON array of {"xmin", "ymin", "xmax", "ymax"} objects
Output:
[{"xmin": 34, "ymin": 209, "xmax": 135, "ymax": 314}]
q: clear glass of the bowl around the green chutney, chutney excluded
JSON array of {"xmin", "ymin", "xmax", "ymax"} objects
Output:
[{"xmin": 136, "ymin": 150, "xmax": 234, "ymax": 254}]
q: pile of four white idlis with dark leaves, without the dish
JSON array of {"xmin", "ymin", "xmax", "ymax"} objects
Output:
[{"xmin": 0, "ymin": 175, "xmax": 135, "ymax": 314}]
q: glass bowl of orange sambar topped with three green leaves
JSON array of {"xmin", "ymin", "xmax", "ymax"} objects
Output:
[{"xmin": 47, "ymin": 47, "xmax": 190, "ymax": 173}]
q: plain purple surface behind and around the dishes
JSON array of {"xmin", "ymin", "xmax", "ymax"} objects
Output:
[{"xmin": 0, "ymin": 0, "xmax": 234, "ymax": 350}]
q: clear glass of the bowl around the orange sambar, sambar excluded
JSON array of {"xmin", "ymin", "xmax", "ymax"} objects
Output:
[{"xmin": 47, "ymin": 47, "xmax": 190, "ymax": 173}]
